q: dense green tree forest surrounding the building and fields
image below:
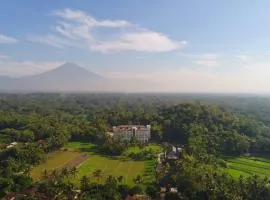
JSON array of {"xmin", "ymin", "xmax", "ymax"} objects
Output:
[{"xmin": 0, "ymin": 93, "xmax": 270, "ymax": 199}]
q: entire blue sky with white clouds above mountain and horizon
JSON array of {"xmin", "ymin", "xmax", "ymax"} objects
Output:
[{"xmin": 0, "ymin": 0, "xmax": 270, "ymax": 93}]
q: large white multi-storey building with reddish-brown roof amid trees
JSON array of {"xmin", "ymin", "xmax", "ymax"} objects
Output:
[{"xmin": 113, "ymin": 125, "xmax": 151, "ymax": 143}]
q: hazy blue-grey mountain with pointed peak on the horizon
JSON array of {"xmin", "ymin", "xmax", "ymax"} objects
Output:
[{"xmin": 0, "ymin": 63, "xmax": 109, "ymax": 92}]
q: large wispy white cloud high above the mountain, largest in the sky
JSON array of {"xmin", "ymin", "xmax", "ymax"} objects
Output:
[{"xmin": 28, "ymin": 9, "xmax": 187, "ymax": 52}]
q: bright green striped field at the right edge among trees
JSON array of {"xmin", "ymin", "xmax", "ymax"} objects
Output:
[{"xmin": 225, "ymin": 156, "xmax": 270, "ymax": 178}]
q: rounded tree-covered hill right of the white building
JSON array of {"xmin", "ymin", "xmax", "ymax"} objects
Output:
[{"xmin": 160, "ymin": 103, "xmax": 270, "ymax": 155}]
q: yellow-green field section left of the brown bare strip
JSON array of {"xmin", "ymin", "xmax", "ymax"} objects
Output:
[{"xmin": 30, "ymin": 151, "xmax": 80, "ymax": 181}]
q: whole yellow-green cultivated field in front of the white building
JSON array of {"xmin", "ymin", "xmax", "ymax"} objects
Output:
[{"xmin": 31, "ymin": 142, "xmax": 158, "ymax": 185}]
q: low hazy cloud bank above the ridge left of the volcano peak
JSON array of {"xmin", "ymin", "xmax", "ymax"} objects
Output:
[{"xmin": 0, "ymin": 57, "xmax": 64, "ymax": 77}]
